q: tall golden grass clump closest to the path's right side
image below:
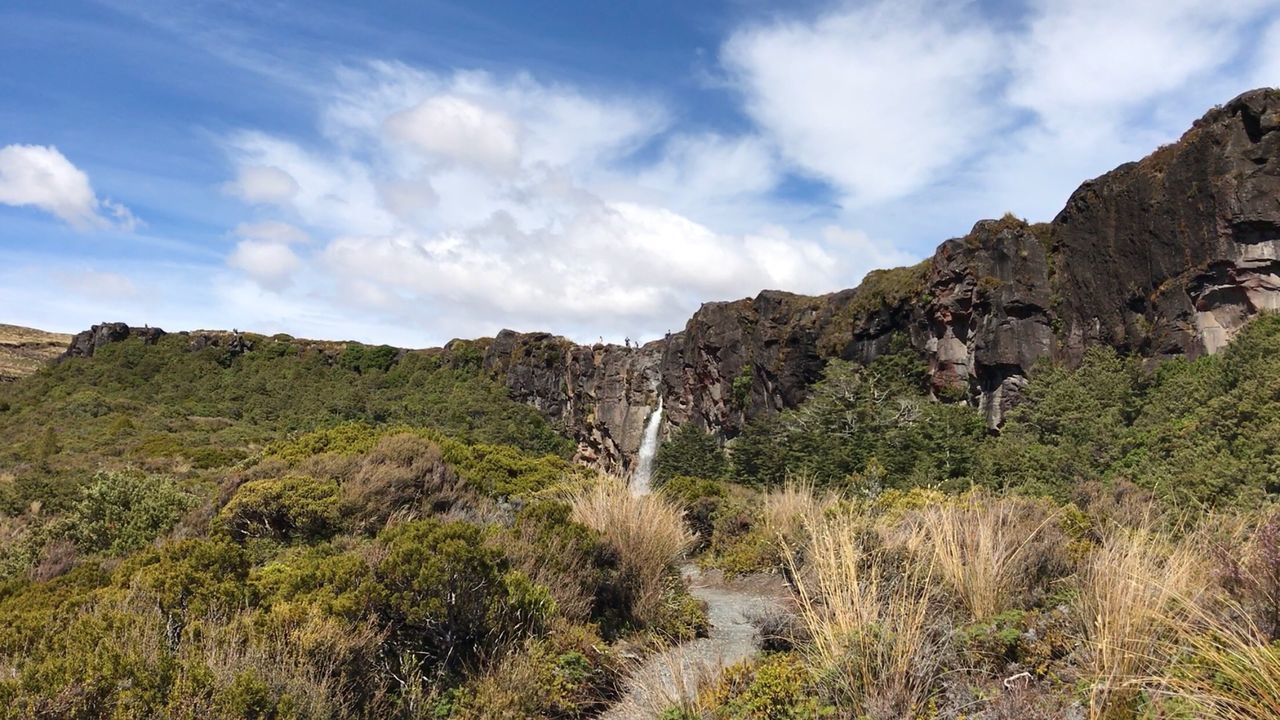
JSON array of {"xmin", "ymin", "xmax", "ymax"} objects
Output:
[{"xmin": 788, "ymin": 514, "xmax": 943, "ymax": 717}]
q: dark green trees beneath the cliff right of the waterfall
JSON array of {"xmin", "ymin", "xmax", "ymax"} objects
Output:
[{"xmin": 730, "ymin": 315, "xmax": 1280, "ymax": 505}]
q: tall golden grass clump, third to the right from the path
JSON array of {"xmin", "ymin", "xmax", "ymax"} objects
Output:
[{"xmin": 1076, "ymin": 529, "xmax": 1211, "ymax": 717}]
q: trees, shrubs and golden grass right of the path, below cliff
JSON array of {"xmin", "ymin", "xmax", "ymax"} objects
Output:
[{"xmin": 645, "ymin": 316, "xmax": 1280, "ymax": 720}]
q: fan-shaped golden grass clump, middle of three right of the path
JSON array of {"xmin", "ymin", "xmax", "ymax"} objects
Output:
[{"xmin": 913, "ymin": 492, "xmax": 1055, "ymax": 620}]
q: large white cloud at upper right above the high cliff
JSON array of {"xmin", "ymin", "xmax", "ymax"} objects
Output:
[{"xmin": 721, "ymin": 0, "xmax": 1280, "ymax": 224}]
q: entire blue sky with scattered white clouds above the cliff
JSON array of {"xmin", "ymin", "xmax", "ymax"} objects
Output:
[{"xmin": 0, "ymin": 0, "xmax": 1280, "ymax": 347}]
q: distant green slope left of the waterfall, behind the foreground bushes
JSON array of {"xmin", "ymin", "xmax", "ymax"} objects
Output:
[{"xmin": 0, "ymin": 334, "xmax": 572, "ymax": 469}]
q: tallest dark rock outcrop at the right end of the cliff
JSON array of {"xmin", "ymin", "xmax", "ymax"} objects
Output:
[{"xmin": 1052, "ymin": 90, "xmax": 1280, "ymax": 357}]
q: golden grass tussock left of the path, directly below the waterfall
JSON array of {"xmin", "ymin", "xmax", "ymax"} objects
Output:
[{"xmin": 568, "ymin": 478, "xmax": 694, "ymax": 623}]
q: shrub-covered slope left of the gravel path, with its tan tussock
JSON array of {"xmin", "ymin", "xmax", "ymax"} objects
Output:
[{"xmin": 0, "ymin": 334, "xmax": 704, "ymax": 719}]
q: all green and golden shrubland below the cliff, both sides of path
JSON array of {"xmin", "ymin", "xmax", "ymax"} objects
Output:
[{"xmin": 0, "ymin": 316, "xmax": 1280, "ymax": 720}]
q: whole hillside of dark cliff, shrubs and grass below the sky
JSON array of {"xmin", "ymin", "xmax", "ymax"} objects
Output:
[{"xmin": 0, "ymin": 85, "xmax": 1280, "ymax": 720}]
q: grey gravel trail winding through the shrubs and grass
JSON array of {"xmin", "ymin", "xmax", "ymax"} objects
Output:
[{"xmin": 600, "ymin": 565, "xmax": 791, "ymax": 720}]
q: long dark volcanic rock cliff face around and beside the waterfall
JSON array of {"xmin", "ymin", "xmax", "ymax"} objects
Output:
[{"xmin": 55, "ymin": 90, "xmax": 1280, "ymax": 473}]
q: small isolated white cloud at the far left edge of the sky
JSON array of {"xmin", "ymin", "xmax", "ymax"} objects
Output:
[{"xmin": 0, "ymin": 145, "xmax": 138, "ymax": 231}]
